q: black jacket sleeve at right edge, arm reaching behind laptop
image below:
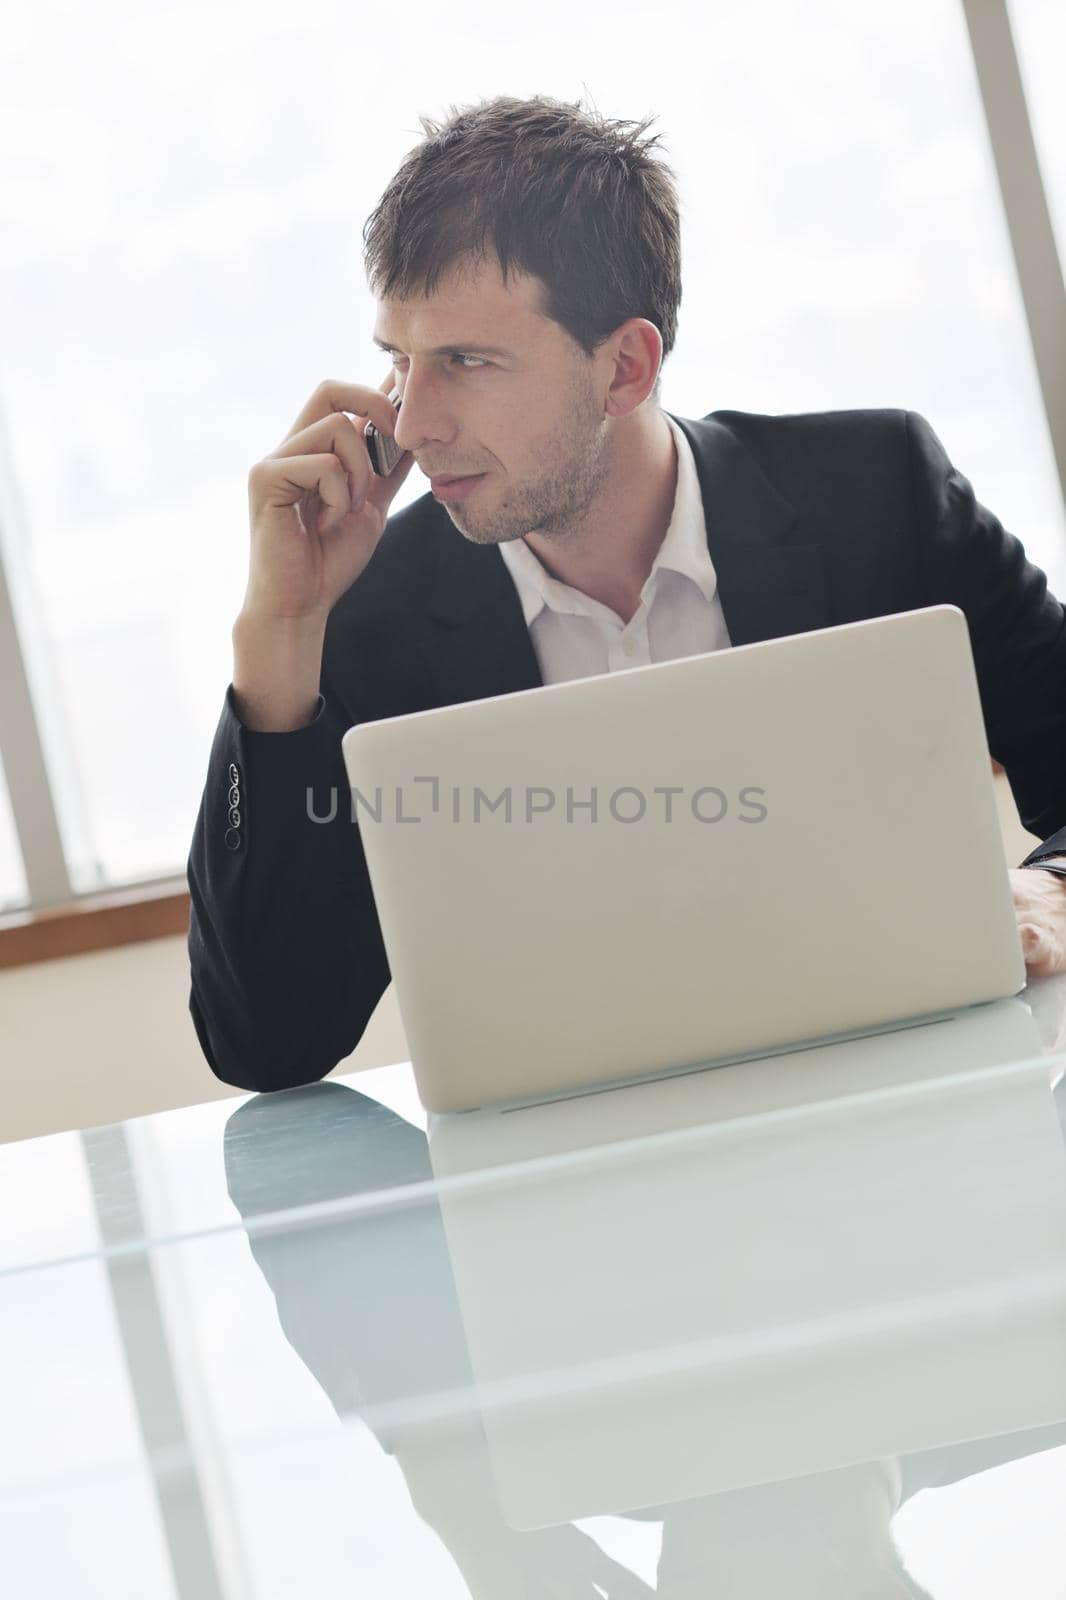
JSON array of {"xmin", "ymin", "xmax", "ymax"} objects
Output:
[{"xmin": 908, "ymin": 413, "xmax": 1066, "ymax": 862}]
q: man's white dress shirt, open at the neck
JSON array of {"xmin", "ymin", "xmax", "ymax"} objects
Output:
[{"xmin": 499, "ymin": 416, "xmax": 730, "ymax": 683}]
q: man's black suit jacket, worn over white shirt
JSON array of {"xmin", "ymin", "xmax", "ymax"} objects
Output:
[{"xmin": 189, "ymin": 411, "xmax": 1066, "ymax": 1090}]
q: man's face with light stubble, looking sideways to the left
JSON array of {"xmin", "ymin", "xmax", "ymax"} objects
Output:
[{"xmin": 375, "ymin": 258, "xmax": 608, "ymax": 544}]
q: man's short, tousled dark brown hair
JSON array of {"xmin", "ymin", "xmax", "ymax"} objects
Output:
[{"xmin": 363, "ymin": 94, "xmax": 680, "ymax": 387}]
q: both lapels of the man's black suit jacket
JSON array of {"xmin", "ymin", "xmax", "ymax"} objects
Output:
[{"xmin": 426, "ymin": 413, "xmax": 831, "ymax": 704}]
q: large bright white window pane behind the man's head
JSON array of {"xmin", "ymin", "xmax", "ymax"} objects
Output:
[{"xmin": 0, "ymin": 0, "xmax": 1066, "ymax": 890}]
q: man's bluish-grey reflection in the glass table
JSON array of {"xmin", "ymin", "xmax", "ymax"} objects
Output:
[{"xmin": 224, "ymin": 1083, "xmax": 1066, "ymax": 1600}]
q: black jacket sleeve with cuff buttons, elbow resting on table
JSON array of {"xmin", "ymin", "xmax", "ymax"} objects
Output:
[{"xmin": 189, "ymin": 685, "xmax": 389, "ymax": 1090}]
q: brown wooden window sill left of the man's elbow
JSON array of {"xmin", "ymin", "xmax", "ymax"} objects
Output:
[{"xmin": 0, "ymin": 878, "xmax": 189, "ymax": 968}]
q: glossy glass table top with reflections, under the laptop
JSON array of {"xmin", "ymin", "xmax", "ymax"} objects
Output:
[{"xmin": 0, "ymin": 979, "xmax": 1066, "ymax": 1600}]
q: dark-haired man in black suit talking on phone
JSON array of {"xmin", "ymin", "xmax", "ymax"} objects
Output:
[{"xmin": 189, "ymin": 98, "xmax": 1066, "ymax": 1090}]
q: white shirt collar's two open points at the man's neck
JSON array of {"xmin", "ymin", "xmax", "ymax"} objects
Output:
[{"xmin": 499, "ymin": 411, "xmax": 719, "ymax": 627}]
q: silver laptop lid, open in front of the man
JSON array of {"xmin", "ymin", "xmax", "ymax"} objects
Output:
[{"xmin": 343, "ymin": 606, "xmax": 1026, "ymax": 1110}]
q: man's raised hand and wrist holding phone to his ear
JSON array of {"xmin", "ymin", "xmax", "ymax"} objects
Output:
[{"xmin": 234, "ymin": 373, "xmax": 415, "ymax": 731}]
